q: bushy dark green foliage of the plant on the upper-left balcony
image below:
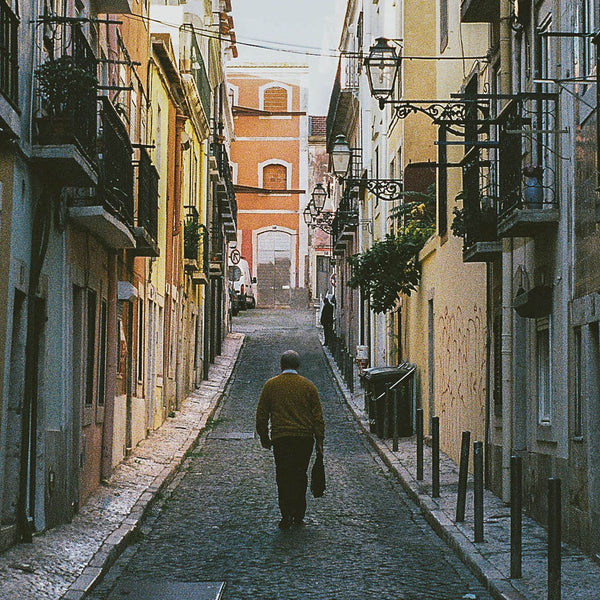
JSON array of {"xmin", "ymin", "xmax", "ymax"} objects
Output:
[{"xmin": 35, "ymin": 56, "xmax": 98, "ymax": 116}]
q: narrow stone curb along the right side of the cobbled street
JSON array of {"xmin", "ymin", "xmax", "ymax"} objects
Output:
[{"xmin": 323, "ymin": 347, "xmax": 527, "ymax": 600}]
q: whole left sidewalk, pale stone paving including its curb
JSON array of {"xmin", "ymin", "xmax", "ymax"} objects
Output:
[{"xmin": 0, "ymin": 333, "xmax": 244, "ymax": 600}]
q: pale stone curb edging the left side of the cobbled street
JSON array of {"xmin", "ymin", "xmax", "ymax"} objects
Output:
[{"xmin": 60, "ymin": 334, "xmax": 245, "ymax": 600}]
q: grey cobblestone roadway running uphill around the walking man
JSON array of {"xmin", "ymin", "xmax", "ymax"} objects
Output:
[{"xmin": 91, "ymin": 310, "xmax": 490, "ymax": 600}]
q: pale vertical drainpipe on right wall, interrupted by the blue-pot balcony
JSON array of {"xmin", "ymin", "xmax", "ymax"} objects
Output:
[{"xmin": 500, "ymin": 0, "xmax": 514, "ymax": 502}]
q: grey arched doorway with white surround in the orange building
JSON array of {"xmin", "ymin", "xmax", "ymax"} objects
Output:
[{"xmin": 256, "ymin": 230, "xmax": 292, "ymax": 306}]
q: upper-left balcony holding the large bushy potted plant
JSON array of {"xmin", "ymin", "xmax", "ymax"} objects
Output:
[{"xmin": 31, "ymin": 21, "xmax": 98, "ymax": 187}]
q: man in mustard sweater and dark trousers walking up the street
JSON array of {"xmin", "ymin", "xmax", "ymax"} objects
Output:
[{"xmin": 256, "ymin": 350, "xmax": 325, "ymax": 529}]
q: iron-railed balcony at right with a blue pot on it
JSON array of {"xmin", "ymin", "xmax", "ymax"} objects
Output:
[{"xmin": 498, "ymin": 94, "xmax": 560, "ymax": 237}]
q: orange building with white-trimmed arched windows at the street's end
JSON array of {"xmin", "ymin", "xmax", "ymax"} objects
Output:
[{"xmin": 227, "ymin": 64, "xmax": 309, "ymax": 307}]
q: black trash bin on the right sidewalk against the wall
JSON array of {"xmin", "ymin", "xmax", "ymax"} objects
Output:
[{"xmin": 361, "ymin": 363, "xmax": 413, "ymax": 438}]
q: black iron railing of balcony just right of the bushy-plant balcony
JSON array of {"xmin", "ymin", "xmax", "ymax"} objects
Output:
[{"xmin": 98, "ymin": 97, "xmax": 134, "ymax": 228}]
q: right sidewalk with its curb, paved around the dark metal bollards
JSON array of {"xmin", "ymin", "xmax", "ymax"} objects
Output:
[{"xmin": 323, "ymin": 347, "xmax": 600, "ymax": 600}]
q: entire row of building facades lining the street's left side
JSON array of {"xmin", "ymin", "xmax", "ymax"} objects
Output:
[{"xmin": 0, "ymin": 0, "xmax": 235, "ymax": 547}]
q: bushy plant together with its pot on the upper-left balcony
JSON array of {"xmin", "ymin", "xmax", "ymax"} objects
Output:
[{"xmin": 35, "ymin": 56, "xmax": 98, "ymax": 143}]
